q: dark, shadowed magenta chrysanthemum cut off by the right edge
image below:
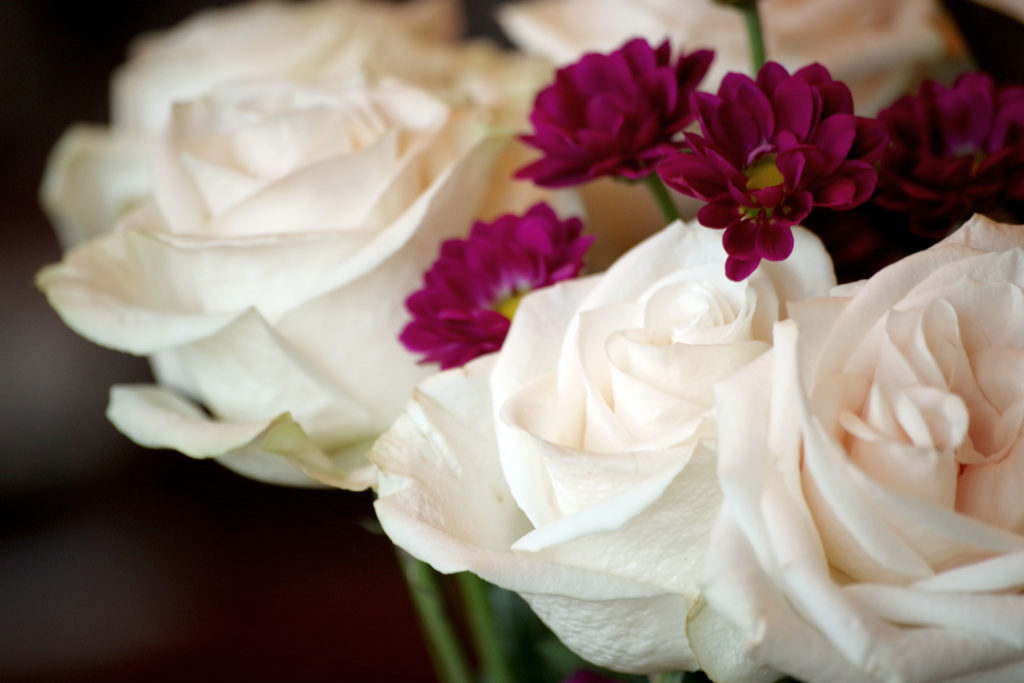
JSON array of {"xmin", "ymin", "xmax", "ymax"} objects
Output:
[{"xmin": 874, "ymin": 74, "xmax": 1024, "ymax": 238}]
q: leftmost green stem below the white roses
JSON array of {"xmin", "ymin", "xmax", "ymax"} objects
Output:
[{"xmin": 397, "ymin": 550, "xmax": 473, "ymax": 683}]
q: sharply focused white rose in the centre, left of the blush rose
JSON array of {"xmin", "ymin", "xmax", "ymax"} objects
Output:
[{"xmin": 370, "ymin": 222, "xmax": 835, "ymax": 673}]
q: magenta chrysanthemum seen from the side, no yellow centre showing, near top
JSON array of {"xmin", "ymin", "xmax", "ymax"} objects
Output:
[{"xmin": 516, "ymin": 38, "xmax": 714, "ymax": 187}]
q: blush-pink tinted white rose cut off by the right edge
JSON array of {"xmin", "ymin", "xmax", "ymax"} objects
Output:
[{"xmin": 689, "ymin": 216, "xmax": 1024, "ymax": 682}]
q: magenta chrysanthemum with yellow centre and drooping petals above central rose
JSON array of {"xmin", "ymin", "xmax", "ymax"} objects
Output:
[{"xmin": 658, "ymin": 61, "xmax": 887, "ymax": 281}]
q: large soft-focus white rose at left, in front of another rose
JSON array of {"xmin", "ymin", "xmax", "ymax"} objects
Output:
[{"xmin": 38, "ymin": 78, "xmax": 561, "ymax": 488}]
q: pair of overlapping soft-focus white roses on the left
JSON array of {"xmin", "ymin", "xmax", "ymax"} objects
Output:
[{"xmin": 37, "ymin": 0, "xmax": 561, "ymax": 488}]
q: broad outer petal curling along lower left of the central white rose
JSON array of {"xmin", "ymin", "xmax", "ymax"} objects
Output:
[{"xmin": 370, "ymin": 357, "xmax": 692, "ymax": 672}]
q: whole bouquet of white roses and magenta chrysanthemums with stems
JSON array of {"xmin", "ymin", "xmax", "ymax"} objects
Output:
[{"xmin": 37, "ymin": 0, "xmax": 1024, "ymax": 683}]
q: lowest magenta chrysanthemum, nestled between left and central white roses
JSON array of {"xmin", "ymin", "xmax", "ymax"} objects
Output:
[{"xmin": 399, "ymin": 203, "xmax": 594, "ymax": 370}]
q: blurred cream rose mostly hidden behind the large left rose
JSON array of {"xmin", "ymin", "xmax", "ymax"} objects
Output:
[{"xmin": 41, "ymin": 0, "xmax": 549, "ymax": 246}]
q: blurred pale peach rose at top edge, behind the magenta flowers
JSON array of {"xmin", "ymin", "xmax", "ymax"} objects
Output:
[{"xmin": 499, "ymin": 0, "xmax": 955, "ymax": 116}]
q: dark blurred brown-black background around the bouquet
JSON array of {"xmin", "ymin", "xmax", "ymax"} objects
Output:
[{"xmin": 0, "ymin": 0, "xmax": 1022, "ymax": 683}]
